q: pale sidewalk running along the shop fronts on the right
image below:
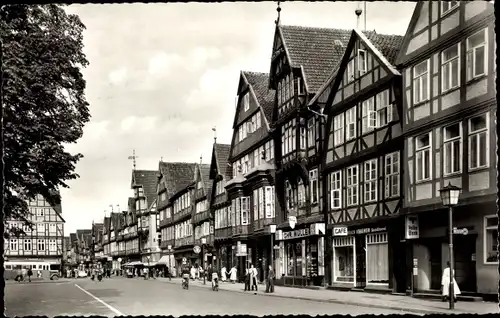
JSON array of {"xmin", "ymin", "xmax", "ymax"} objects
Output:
[{"xmin": 157, "ymin": 278, "xmax": 499, "ymax": 314}]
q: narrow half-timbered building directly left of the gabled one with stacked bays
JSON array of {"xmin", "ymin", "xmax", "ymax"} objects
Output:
[{"xmin": 209, "ymin": 141, "xmax": 234, "ymax": 273}]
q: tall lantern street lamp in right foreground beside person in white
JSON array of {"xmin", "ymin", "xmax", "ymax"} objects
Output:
[{"xmin": 439, "ymin": 182, "xmax": 461, "ymax": 309}]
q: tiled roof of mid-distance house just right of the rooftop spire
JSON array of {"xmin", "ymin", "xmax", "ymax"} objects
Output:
[{"xmin": 160, "ymin": 161, "xmax": 196, "ymax": 198}]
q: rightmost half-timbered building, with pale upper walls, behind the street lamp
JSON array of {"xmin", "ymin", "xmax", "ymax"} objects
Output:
[{"xmin": 397, "ymin": 1, "xmax": 498, "ymax": 295}]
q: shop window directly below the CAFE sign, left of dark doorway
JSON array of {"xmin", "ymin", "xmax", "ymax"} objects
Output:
[{"xmin": 333, "ymin": 236, "xmax": 354, "ymax": 282}]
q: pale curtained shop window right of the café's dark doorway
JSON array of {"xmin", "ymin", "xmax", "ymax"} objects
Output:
[{"xmin": 366, "ymin": 232, "xmax": 389, "ymax": 284}]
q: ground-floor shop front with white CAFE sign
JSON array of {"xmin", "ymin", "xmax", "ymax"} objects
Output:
[{"xmin": 332, "ymin": 226, "xmax": 392, "ymax": 289}]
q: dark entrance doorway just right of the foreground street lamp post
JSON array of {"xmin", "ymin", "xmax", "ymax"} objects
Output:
[{"xmin": 453, "ymin": 235, "xmax": 477, "ymax": 293}]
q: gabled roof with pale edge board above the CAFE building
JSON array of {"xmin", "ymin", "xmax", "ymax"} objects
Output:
[{"xmin": 309, "ymin": 30, "xmax": 403, "ymax": 106}]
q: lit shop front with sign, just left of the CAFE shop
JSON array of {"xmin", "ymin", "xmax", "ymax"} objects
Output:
[{"xmin": 276, "ymin": 223, "xmax": 325, "ymax": 287}]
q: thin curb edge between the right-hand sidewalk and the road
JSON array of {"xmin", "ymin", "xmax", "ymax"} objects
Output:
[{"xmin": 159, "ymin": 281, "xmax": 454, "ymax": 314}]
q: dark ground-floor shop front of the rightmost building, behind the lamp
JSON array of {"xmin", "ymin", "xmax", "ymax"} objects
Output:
[{"xmin": 406, "ymin": 202, "xmax": 498, "ymax": 296}]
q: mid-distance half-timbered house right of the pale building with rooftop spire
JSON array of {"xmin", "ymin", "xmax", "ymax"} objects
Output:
[{"xmin": 157, "ymin": 161, "xmax": 198, "ymax": 274}]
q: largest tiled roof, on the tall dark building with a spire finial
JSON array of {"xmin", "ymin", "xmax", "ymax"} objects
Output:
[{"xmin": 280, "ymin": 25, "xmax": 352, "ymax": 93}]
